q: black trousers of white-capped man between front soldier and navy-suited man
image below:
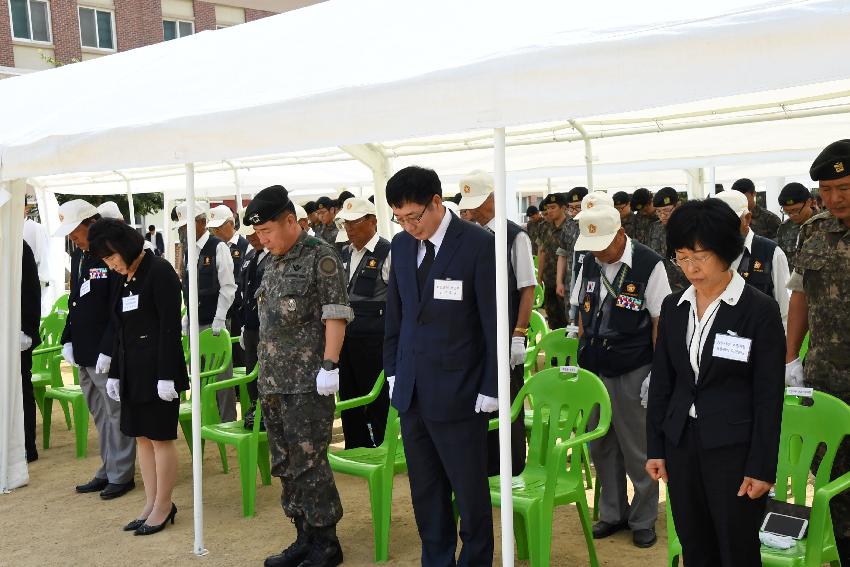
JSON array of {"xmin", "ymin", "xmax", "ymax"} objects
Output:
[{"xmin": 339, "ymin": 336, "xmax": 390, "ymax": 449}]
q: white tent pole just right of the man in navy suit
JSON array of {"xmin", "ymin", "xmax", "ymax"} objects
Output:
[{"xmin": 493, "ymin": 128, "xmax": 514, "ymax": 567}]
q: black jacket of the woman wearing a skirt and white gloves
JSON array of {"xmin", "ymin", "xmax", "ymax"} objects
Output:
[{"xmin": 109, "ymin": 252, "xmax": 189, "ymax": 403}]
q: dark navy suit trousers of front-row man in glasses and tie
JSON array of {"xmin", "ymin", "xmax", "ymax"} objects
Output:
[{"xmin": 400, "ymin": 398, "xmax": 493, "ymax": 567}]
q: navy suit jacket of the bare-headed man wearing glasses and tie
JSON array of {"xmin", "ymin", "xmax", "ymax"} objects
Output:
[{"xmin": 384, "ymin": 211, "xmax": 497, "ymax": 421}]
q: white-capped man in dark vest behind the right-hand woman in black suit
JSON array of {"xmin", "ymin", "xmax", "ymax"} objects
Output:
[{"xmin": 715, "ymin": 191, "xmax": 791, "ymax": 327}]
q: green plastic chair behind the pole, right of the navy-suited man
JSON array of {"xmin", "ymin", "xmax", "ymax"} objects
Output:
[{"xmin": 489, "ymin": 368, "xmax": 611, "ymax": 567}]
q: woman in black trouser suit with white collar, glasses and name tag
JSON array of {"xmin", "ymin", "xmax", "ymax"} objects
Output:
[{"xmin": 646, "ymin": 199, "xmax": 785, "ymax": 567}]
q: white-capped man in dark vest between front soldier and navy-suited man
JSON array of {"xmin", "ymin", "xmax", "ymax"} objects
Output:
[{"xmin": 336, "ymin": 197, "xmax": 390, "ymax": 449}]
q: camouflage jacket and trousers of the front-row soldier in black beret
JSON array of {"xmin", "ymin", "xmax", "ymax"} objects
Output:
[{"xmin": 257, "ymin": 232, "xmax": 354, "ymax": 528}]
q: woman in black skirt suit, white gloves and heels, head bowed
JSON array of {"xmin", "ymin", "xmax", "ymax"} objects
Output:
[{"xmin": 89, "ymin": 219, "xmax": 189, "ymax": 535}]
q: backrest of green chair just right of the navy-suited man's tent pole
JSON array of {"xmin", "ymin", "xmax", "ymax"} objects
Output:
[{"xmin": 515, "ymin": 368, "xmax": 611, "ymax": 483}]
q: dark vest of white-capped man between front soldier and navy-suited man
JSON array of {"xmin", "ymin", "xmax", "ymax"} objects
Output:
[{"xmin": 342, "ymin": 238, "xmax": 390, "ymax": 337}]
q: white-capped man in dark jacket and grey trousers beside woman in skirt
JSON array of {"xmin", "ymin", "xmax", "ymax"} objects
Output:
[{"xmin": 53, "ymin": 199, "xmax": 136, "ymax": 500}]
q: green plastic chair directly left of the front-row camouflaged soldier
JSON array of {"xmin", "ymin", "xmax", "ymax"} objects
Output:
[{"xmin": 201, "ymin": 365, "xmax": 272, "ymax": 518}]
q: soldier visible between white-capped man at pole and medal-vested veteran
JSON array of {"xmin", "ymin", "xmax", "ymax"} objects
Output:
[{"xmin": 537, "ymin": 193, "xmax": 567, "ymax": 329}]
